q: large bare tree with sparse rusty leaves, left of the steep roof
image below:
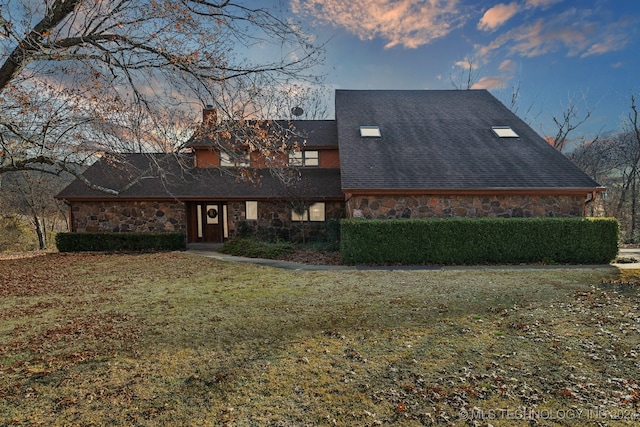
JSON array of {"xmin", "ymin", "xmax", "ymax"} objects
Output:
[{"xmin": 0, "ymin": 0, "xmax": 322, "ymax": 194}]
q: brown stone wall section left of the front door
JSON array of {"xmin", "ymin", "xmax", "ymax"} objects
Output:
[{"xmin": 71, "ymin": 201, "xmax": 187, "ymax": 233}]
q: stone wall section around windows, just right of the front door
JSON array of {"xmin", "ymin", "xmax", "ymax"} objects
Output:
[{"xmin": 227, "ymin": 201, "xmax": 345, "ymax": 241}]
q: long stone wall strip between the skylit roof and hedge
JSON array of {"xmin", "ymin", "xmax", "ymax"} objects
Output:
[{"xmin": 347, "ymin": 195, "xmax": 585, "ymax": 219}]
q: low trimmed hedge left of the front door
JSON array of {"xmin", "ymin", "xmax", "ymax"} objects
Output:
[{"xmin": 56, "ymin": 233, "xmax": 186, "ymax": 252}]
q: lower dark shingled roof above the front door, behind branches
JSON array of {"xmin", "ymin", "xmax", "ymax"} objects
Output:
[{"xmin": 56, "ymin": 154, "xmax": 344, "ymax": 200}]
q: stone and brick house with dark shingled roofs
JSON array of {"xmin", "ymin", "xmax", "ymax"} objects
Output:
[{"xmin": 57, "ymin": 90, "xmax": 604, "ymax": 242}]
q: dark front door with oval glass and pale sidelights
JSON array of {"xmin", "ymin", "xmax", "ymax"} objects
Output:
[{"xmin": 187, "ymin": 202, "xmax": 226, "ymax": 243}]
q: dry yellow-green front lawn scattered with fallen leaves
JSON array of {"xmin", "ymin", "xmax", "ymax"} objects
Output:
[{"xmin": 0, "ymin": 253, "xmax": 640, "ymax": 426}]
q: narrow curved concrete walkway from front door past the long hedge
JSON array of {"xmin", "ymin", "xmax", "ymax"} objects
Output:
[{"xmin": 187, "ymin": 244, "xmax": 640, "ymax": 271}]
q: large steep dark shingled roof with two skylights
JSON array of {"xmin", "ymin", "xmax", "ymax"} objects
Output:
[{"xmin": 335, "ymin": 90, "xmax": 600, "ymax": 191}]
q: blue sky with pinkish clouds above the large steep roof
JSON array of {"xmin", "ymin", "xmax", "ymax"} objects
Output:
[{"xmin": 269, "ymin": 0, "xmax": 640, "ymax": 141}]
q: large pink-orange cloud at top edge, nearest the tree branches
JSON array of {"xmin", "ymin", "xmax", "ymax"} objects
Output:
[{"xmin": 291, "ymin": 0, "xmax": 466, "ymax": 48}]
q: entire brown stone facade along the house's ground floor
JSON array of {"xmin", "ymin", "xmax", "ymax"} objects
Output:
[{"xmin": 71, "ymin": 195, "xmax": 585, "ymax": 241}]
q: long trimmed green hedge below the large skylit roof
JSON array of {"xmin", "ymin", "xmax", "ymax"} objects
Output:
[{"xmin": 340, "ymin": 218, "xmax": 619, "ymax": 264}]
